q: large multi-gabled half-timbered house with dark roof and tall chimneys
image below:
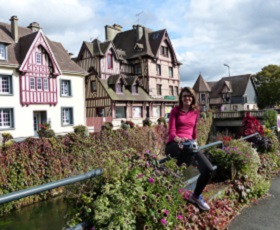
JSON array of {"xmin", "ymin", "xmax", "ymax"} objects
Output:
[{"xmin": 75, "ymin": 24, "xmax": 181, "ymax": 130}]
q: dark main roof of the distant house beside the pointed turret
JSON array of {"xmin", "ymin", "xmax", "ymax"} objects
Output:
[{"xmin": 207, "ymin": 74, "xmax": 251, "ymax": 98}]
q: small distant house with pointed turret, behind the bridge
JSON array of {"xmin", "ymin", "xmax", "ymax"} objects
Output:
[{"xmin": 193, "ymin": 74, "xmax": 258, "ymax": 111}]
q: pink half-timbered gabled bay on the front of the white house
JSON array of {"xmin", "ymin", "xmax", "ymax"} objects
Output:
[{"xmin": 20, "ymin": 32, "xmax": 60, "ymax": 105}]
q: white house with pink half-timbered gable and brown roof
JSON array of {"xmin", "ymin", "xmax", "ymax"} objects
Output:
[{"xmin": 0, "ymin": 16, "xmax": 87, "ymax": 137}]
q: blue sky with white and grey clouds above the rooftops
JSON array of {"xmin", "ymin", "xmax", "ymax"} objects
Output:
[{"xmin": 0, "ymin": 0, "xmax": 280, "ymax": 87}]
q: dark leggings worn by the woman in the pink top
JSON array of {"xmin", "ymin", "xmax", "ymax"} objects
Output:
[{"xmin": 165, "ymin": 142, "xmax": 213, "ymax": 197}]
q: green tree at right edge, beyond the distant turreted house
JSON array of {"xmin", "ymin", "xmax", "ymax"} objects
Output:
[{"xmin": 253, "ymin": 65, "xmax": 280, "ymax": 108}]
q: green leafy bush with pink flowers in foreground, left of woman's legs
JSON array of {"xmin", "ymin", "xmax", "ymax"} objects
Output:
[{"xmin": 64, "ymin": 149, "xmax": 184, "ymax": 229}]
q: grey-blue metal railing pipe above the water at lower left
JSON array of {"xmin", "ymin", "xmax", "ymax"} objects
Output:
[{"xmin": 0, "ymin": 169, "xmax": 103, "ymax": 204}]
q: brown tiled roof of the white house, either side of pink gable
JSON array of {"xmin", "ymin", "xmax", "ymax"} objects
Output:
[{"xmin": 0, "ymin": 19, "xmax": 87, "ymax": 75}]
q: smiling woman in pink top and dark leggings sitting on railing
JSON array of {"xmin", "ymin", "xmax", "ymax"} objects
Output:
[{"xmin": 165, "ymin": 87, "xmax": 213, "ymax": 211}]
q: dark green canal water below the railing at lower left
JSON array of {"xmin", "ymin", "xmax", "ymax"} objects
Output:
[{"xmin": 0, "ymin": 197, "xmax": 67, "ymax": 230}]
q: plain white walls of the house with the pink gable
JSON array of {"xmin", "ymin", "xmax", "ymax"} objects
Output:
[{"xmin": 0, "ymin": 68, "xmax": 86, "ymax": 138}]
